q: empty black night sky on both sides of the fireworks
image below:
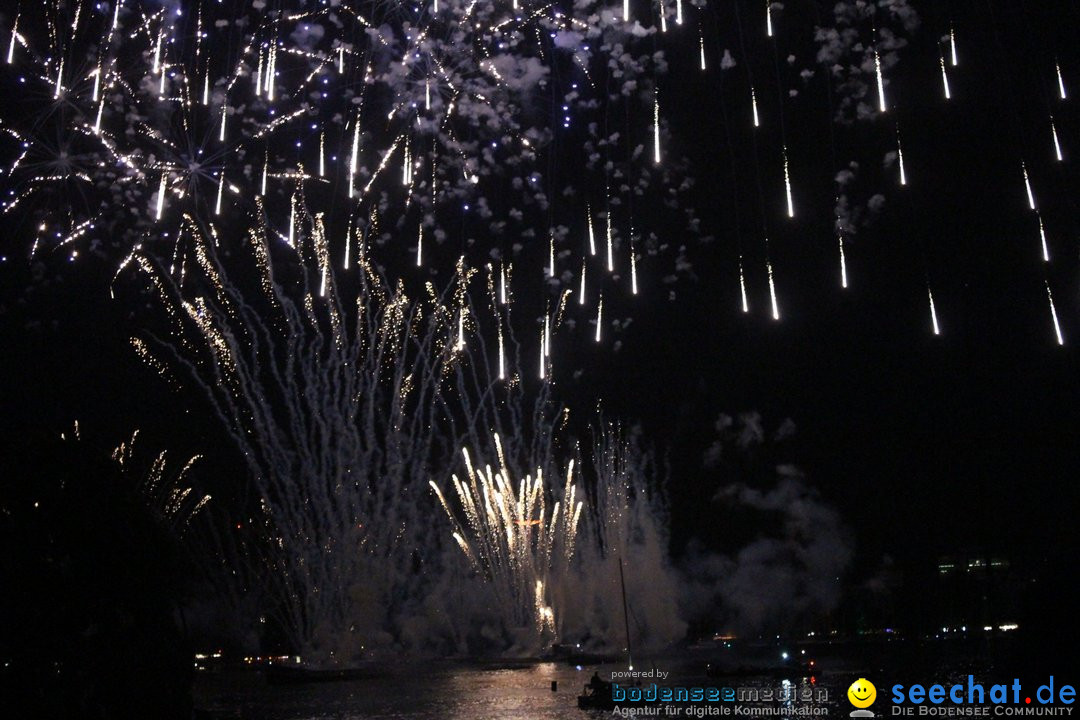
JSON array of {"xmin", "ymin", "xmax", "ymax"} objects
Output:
[{"xmin": 0, "ymin": 1, "xmax": 1080, "ymax": 626}]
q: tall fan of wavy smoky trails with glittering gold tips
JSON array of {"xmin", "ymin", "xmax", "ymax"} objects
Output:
[{"xmin": 132, "ymin": 208, "xmax": 467, "ymax": 662}]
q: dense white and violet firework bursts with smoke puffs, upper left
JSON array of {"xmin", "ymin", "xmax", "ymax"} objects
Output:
[{"xmin": 0, "ymin": 0, "xmax": 681, "ymax": 319}]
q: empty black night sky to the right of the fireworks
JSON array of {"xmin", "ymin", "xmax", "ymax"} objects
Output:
[{"xmin": 620, "ymin": 2, "xmax": 1080, "ymax": 567}]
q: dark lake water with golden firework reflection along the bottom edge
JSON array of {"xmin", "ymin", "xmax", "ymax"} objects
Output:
[{"xmin": 195, "ymin": 652, "xmax": 978, "ymax": 720}]
